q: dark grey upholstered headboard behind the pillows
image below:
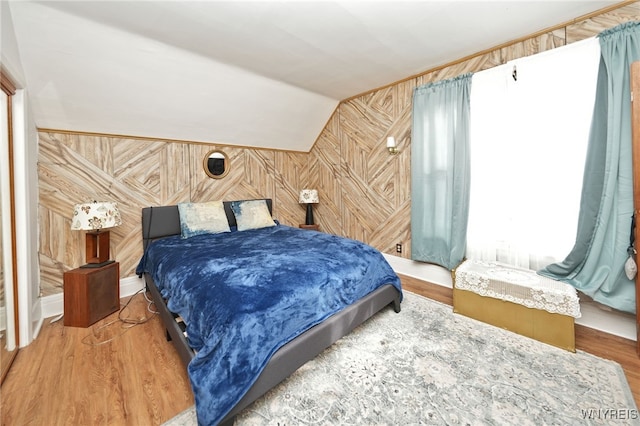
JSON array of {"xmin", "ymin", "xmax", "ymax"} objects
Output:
[{"xmin": 142, "ymin": 198, "xmax": 273, "ymax": 250}]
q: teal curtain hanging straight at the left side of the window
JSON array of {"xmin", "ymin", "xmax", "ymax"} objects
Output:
[{"xmin": 411, "ymin": 74, "xmax": 472, "ymax": 269}]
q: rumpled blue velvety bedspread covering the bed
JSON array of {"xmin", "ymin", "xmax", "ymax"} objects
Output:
[{"xmin": 137, "ymin": 225, "xmax": 401, "ymax": 425}]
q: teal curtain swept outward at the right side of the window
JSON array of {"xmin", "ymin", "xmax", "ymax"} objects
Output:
[{"xmin": 539, "ymin": 22, "xmax": 640, "ymax": 313}]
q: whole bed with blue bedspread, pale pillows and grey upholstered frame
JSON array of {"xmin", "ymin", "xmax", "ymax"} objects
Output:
[{"xmin": 137, "ymin": 199, "xmax": 402, "ymax": 425}]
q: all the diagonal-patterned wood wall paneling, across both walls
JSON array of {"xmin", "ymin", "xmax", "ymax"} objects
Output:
[{"xmin": 38, "ymin": 2, "xmax": 640, "ymax": 296}]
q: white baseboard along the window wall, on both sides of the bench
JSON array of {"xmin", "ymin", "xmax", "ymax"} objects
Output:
[{"xmin": 384, "ymin": 254, "xmax": 637, "ymax": 341}]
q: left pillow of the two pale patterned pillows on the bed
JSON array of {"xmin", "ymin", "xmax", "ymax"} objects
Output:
[{"xmin": 178, "ymin": 201, "xmax": 231, "ymax": 238}]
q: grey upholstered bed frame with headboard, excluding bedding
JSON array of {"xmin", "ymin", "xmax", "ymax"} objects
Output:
[{"xmin": 142, "ymin": 199, "xmax": 400, "ymax": 425}]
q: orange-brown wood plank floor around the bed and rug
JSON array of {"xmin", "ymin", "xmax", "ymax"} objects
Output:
[{"xmin": 0, "ymin": 276, "xmax": 640, "ymax": 426}]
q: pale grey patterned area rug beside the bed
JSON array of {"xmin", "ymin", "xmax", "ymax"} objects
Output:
[{"xmin": 165, "ymin": 292, "xmax": 640, "ymax": 426}]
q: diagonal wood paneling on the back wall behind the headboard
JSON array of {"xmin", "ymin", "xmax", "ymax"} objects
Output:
[{"xmin": 38, "ymin": 132, "xmax": 308, "ymax": 296}]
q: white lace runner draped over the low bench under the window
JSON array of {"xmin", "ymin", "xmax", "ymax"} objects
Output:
[{"xmin": 455, "ymin": 260, "xmax": 581, "ymax": 318}]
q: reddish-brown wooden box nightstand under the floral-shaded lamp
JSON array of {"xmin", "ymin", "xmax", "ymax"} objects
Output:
[{"xmin": 64, "ymin": 262, "xmax": 120, "ymax": 327}]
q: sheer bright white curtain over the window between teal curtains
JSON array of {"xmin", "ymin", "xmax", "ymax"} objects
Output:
[{"xmin": 466, "ymin": 39, "xmax": 600, "ymax": 270}]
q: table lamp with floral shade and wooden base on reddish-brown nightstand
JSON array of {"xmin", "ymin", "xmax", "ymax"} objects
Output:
[{"xmin": 71, "ymin": 201, "xmax": 122, "ymax": 268}]
